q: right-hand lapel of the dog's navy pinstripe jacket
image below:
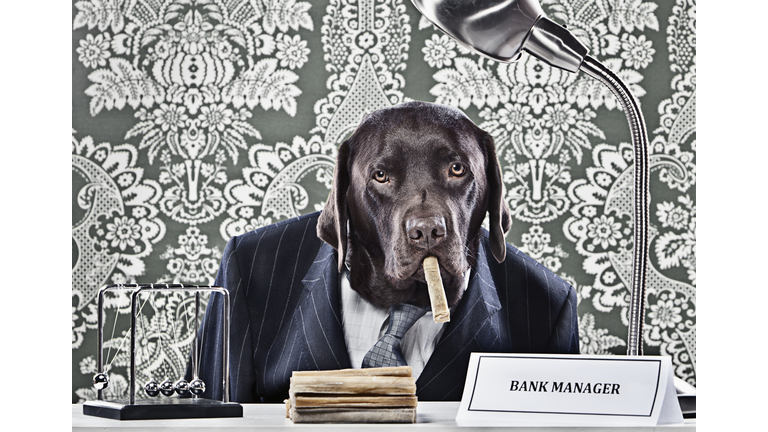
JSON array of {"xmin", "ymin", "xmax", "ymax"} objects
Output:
[{"xmin": 416, "ymin": 242, "xmax": 501, "ymax": 400}]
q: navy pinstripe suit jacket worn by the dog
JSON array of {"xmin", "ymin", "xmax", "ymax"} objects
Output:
[{"xmin": 195, "ymin": 213, "xmax": 579, "ymax": 402}]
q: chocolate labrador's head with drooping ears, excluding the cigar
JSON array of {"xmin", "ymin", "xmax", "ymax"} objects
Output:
[{"xmin": 317, "ymin": 102, "xmax": 511, "ymax": 308}]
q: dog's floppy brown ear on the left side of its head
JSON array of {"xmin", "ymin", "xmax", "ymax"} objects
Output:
[{"xmin": 317, "ymin": 140, "xmax": 349, "ymax": 273}]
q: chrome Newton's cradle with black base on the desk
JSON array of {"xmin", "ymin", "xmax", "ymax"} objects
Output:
[{"xmin": 83, "ymin": 284, "xmax": 243, "ymax": 420}]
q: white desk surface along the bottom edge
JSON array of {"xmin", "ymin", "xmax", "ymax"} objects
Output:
[{"xmin": 72, "ymin": 402, "xmax": 696, "ymax": 432}]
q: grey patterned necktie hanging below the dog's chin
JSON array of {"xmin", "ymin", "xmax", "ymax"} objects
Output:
[{"xmin": 363, "ymin": 303, "xmax": 427, "ymax": 368}]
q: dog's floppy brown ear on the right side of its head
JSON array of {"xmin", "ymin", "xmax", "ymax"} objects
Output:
[{"xmin": 481, "ymin": 131, "xmax": 512, "ymax": 262}]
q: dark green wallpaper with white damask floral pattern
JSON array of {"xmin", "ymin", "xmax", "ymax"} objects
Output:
[{"xmin": 72, "ymin": 0, "xmax": 696, "ymax": 402}]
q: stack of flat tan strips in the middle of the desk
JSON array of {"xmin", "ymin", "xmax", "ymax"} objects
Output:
[{"xmin": 285, "ymin": 366, "xmax": 417, "ymax": 423}]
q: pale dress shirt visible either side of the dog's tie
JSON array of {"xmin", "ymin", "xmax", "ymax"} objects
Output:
[{"xmin": 340, "ymin": 269, "xmax": 470, "ymax": 379}]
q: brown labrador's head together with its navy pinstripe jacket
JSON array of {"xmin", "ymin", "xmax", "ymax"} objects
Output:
[{"xmin": 188, "ymin": 103, "xmax": 579, "ymax": 402}]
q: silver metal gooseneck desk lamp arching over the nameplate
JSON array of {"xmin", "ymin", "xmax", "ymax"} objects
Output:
[{"xmin": 411, "ymin": 0, "xmax": 649, "ymax": 355}]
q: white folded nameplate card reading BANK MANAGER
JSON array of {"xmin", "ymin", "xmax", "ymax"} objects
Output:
[{"xmin": 456, "ymin": 353, "xmax": 683, "ymax": 426}]
